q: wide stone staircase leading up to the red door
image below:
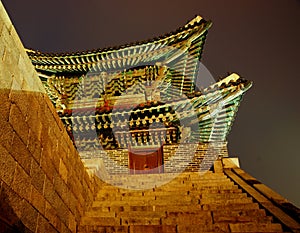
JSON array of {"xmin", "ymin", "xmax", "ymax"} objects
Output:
[{"xmin": 78, "ymin": 171, "xmax": 283, "ymax": 233}]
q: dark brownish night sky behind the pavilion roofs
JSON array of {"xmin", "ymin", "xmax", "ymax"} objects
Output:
[{"xmin": 2, "ymin": 0, "xmax": 300, "ymax": 207}]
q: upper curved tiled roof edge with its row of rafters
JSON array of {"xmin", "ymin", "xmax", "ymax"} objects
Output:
[{"xmin": 27, "ymin": 16, "xmax": 211, "ymax": 73}]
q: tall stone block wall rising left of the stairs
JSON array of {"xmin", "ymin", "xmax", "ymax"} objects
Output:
[{"xmin": 0, "ymin": 2, "xmax": 99, "ymax": 233}]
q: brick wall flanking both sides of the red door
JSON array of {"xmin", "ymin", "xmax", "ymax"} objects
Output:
[{"xmin": 81, "ymin": 142, "xmax": 228, "ymax": 177}]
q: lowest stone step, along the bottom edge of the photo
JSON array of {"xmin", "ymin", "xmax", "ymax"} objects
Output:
[{"xmin": 78, "ymin": 218, "xmax": 283, "ymax": 233}]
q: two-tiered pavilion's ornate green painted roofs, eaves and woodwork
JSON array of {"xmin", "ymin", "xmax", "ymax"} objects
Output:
[{"xmin": 27, "ymin": 16, "xmax": 252, "ymax": 173}]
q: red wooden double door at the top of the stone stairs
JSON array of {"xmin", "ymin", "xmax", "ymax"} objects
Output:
[{"xmin": 128, "ymin": 147, "xmax": 163, "ymax": 174}]
